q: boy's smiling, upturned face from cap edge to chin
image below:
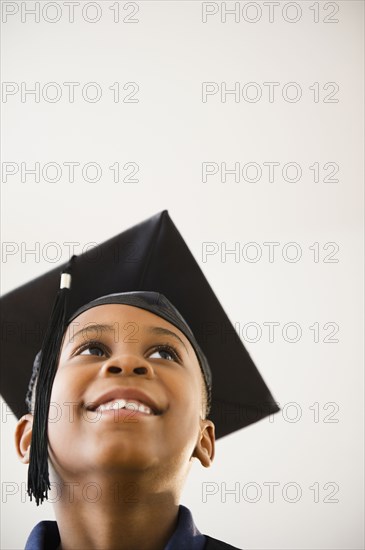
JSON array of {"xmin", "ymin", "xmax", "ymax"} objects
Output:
[{"xmin": 42, "ymin": 304, "xmax": 214, "ymax": 488}]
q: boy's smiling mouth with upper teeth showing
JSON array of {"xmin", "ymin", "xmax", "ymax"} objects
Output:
[{"xmin": 86, "ymin": 387, "xmax": 162, "ymax": 415}]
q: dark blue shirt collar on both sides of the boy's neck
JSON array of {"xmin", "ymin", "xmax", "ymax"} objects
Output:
[{"xmin": 25, "ymin": 504, "xmax": 206, "ymax": 550}]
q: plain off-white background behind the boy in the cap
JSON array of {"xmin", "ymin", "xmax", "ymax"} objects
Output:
[{"xmin": 1, "ymin": 1, "xmax": 364, "ymax": 550}]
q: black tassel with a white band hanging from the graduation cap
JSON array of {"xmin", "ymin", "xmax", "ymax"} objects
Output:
[{"xmin": 28, "ymin": 256, "xmax": 76, "ymax": 506}]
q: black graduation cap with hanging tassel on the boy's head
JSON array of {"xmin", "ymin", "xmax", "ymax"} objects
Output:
[{"xmin": 0, "ymin": 210, "xmax": 279, "ymax": 504}]
